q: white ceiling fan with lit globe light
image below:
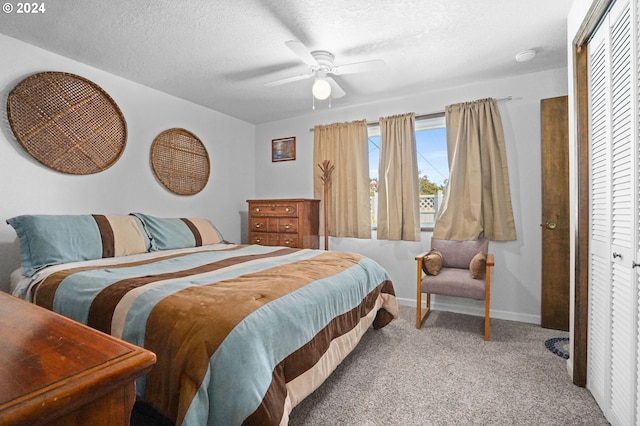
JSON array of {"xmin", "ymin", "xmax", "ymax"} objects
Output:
[{"xmin": 265, "ymin": 40, "xmax": 384, "ymax": 99}]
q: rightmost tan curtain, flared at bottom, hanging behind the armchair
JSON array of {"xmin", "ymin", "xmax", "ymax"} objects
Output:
[{"xmin": 433, "ymin": 99, "xmax": 516, "ymax": 241}]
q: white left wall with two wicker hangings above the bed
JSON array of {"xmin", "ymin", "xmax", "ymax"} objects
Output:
[{"xmin": 0, "ymin": 34, "xmax": 255, "ymax": 291}]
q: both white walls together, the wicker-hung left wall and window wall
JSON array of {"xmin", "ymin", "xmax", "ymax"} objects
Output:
[{"xmin": 0, "ymin": 30, "xmax": 568, "ymax": 323}]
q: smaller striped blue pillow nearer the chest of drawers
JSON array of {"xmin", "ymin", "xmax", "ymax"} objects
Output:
[{"xmin": 132, "ymin": 213, "xmax": 223, "ymax": 251}]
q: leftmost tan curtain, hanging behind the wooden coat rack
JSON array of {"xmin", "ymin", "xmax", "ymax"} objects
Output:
[{"xmin": 313, "ymin": 120, "xmax": 371, "ymax": 238}]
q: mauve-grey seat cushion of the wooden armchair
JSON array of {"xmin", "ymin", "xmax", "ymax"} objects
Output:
[{"xmin": 422, "ymin": 265, "xmax": 486, "ymax": 300}]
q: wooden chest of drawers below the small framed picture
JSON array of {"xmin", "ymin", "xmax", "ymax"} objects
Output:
[{"xmin": 247, "ymin": 198, "xmax": 320, "ymax": 249}]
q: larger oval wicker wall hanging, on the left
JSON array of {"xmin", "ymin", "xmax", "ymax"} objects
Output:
[{"xmin": 7, "ymin": 71, "xmax": 127, "ymax": 175}]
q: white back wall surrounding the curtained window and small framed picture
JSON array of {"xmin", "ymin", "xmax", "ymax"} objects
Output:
[{"xmin": 255, "ymin": 69, "xmax": 568, "ymax": 323}]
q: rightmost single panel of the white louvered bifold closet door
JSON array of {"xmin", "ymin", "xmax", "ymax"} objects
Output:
[{"xmin": 611, "ymin": 2, "xmax": 637, "ymax": 425}]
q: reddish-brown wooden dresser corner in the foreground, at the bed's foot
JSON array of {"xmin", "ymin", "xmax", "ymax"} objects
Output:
[{"xmin": 0, "ymin": 291, "xmax": 156, "ymax": 426}]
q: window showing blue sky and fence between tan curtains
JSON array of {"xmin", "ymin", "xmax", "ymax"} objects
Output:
[{"xmin": 368, "ymin": 114, "xmax": 449, "ymax": 228}]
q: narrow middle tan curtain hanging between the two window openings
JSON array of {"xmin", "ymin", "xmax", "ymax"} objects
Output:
[{"xmin": 378, "ymin": 113, "xmax": 420, "ymax": 241}]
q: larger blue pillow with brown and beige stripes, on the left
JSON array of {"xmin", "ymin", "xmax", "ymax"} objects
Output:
[{"xmin": 7, "ymin": 214, "xmax": 151, "ymax": 276}]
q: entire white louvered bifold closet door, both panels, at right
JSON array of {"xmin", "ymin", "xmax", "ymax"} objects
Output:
[{"xmin": 587, "ymin": 0, "xmax": 638, "ymax": 425}]
